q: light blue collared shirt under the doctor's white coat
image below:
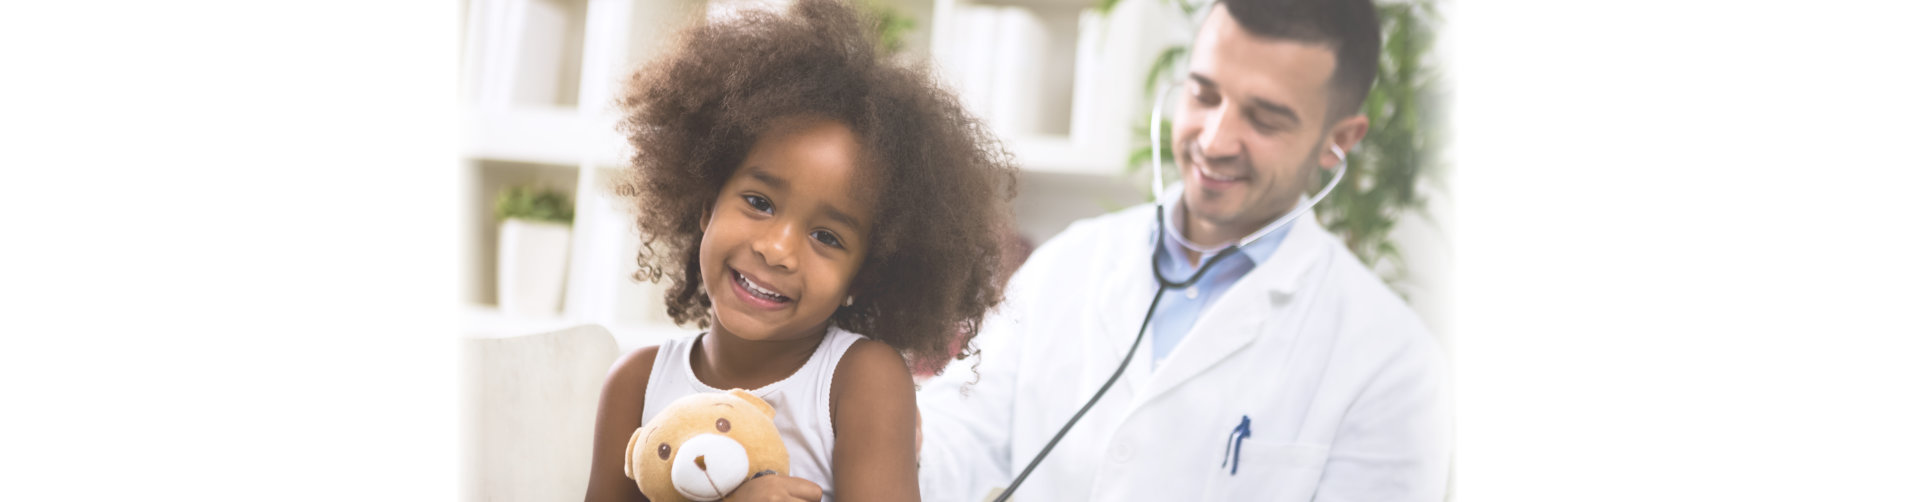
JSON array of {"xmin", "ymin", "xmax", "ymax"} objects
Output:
[{"xmin": 1152, "ymin": 199, "xmax": 1294, "ymax": 369}]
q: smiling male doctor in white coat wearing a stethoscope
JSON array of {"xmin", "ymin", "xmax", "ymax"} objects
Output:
[{"xmin": 920, "ymin": 0, "xmax": 1452, "ymax": 502}]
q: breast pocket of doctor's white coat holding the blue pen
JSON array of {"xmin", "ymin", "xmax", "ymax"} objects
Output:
[{"xmin": 1202, "ymin": 439, "xmax": 1327, "ymax": 502}]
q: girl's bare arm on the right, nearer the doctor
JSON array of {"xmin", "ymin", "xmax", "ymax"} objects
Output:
[{"xmin": 829, "ymin": 340, "xmax": 920, "ymax": 502}]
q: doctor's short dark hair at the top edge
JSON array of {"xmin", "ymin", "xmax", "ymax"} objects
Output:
[{"xmin": 1217, "ymin": 0, "xmax": 1380, "ymax": 123}]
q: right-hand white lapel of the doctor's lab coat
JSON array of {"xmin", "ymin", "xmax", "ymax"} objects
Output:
[{"xmin": 1135, "ymin": 212, "xmax": 1332, "ymax": 406}]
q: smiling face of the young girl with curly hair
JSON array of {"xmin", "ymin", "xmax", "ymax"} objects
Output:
[{"xmin": 699, "ymin": 117, "xmax": 874, "ymax": 340}]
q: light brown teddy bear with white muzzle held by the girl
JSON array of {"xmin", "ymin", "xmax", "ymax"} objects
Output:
[{"xmin": 626, "ymin": 389, "xmax": 787, "ymax": 502}]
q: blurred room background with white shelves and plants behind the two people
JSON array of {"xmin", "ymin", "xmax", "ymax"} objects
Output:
[{"xmin": 459, "ymin": 0, "xmax": 1452, "ymax": 500}]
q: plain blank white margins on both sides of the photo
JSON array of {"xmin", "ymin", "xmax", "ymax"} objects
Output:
[{"xmin": 0, "ymin": 0, "xmax": 1920, "ymax": 500}]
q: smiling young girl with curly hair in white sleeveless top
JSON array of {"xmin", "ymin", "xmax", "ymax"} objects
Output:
[{"xmin": 588, "ymin": 0, "xmax": 1014, "ymax": 502}]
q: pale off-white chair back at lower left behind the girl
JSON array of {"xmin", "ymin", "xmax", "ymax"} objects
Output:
[{"xmin": 461, "ymin": 325, "xmax": 620, "ymax": 502}]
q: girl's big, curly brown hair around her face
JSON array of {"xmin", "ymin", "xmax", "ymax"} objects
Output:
[{"xmin": 618, "ymin": 0, "xmax": 1016, "ymax": 373}]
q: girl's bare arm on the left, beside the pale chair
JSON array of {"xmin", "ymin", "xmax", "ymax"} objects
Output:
[{"xmin": 588, "ymin": 346, "xmax": 660, "ymax": 502}]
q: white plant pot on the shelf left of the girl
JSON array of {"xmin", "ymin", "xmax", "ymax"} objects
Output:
[{"xmin": 499, "ymin": 219, "xmax": 572, "ymax": 315}]
